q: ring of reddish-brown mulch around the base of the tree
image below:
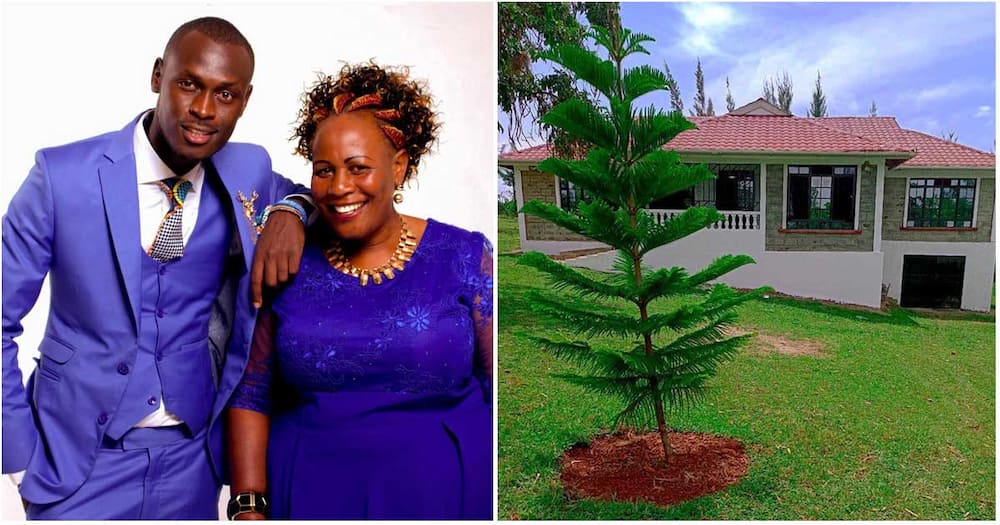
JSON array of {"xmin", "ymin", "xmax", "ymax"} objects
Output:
[{"xmin": 560, "ymin": 432, "xmax": 750, "ymax": 505}]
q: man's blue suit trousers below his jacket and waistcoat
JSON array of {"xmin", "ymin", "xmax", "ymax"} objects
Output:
[{"xmin": 25, "ymin": 426, "xmax": 222, "ymax": 520}]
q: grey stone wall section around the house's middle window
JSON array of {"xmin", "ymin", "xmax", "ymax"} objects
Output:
[{"xmin": 764, "ymin": 164, "xmax": 875, "ymax": 252}]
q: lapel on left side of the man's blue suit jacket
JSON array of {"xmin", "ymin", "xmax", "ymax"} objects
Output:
[{"xmin": 98, "ymin": 119, "xmax": 144, "ymax": 329}]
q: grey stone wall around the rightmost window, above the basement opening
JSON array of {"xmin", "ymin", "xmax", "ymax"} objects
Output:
[{"xmin": 882, "ymin": 178, "xmax": 996, "ymax": 242}]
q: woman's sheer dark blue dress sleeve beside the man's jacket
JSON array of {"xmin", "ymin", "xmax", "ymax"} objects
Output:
[{"xmin": 229, "ymin": 307, "xmax": 276, "ymax": 414}]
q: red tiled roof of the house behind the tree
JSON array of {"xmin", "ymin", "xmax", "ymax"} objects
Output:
[{"xmin": 500, "ymin": 115, "xmax": 996, "ymax": 168}]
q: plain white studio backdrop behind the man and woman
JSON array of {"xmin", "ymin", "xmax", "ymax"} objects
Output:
[{"xmin": 0, "ymin": 2, "xmax": 497, "ymax": 520}]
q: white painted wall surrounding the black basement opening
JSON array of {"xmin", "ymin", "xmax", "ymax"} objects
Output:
[{"xmin": 882, "ymin": 241, "xmax": 996, "ymax": 312}]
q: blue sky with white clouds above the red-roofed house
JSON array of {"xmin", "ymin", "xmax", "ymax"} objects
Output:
[{"xmin": 498, "ymin": 2, "xmax": 996, "ymax": 162}]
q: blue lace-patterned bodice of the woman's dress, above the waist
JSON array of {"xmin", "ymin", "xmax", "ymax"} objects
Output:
[{"xmin": 227, "ymin": 220, "xmax": 494, "ymax": 411}]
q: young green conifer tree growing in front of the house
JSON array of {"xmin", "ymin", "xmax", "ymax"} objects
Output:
[{"xmin": 519, "ymin": 21, "xmax": 768, "ymax": 461}]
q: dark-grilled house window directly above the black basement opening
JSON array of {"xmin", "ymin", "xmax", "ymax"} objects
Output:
[{"xmin": 906, "ymin": 179, "xmax": 976, "ymax": 228}]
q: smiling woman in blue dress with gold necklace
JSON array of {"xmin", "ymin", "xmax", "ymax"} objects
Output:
[{"xmin": 228, "ymin": 64, "xmax": 493, "ymax": 520}]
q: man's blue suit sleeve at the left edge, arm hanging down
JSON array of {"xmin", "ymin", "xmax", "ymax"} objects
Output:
[{"xmin": 3, "ymin": 152, "xmax": 55, "ymax": 473}]
